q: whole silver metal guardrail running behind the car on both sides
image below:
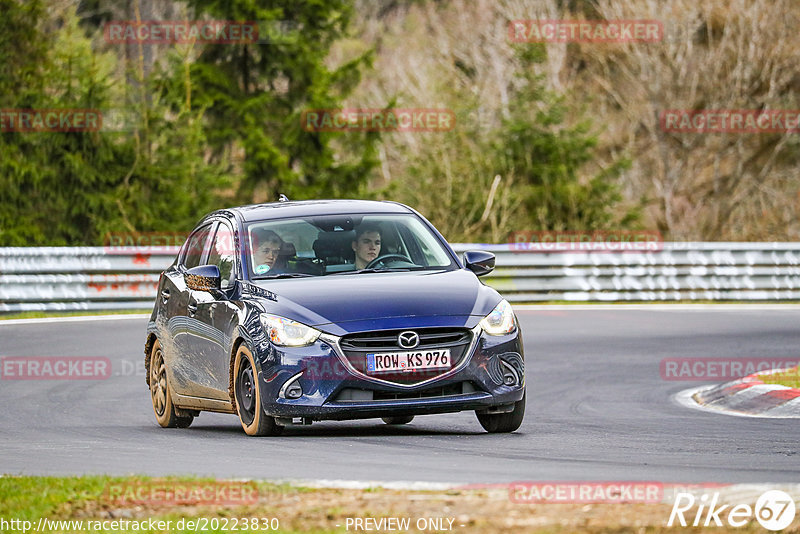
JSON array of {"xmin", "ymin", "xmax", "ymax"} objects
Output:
[{"xmin": 0, "ymin": 243, "xmax": 800, "ymax": 312}]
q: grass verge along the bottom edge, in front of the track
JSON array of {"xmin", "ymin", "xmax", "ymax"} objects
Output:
[{"xmin": 0, "ymin": 476, "xmax": 776, "ymax": 534}]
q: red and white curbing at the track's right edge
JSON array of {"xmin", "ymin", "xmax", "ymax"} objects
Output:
[{"xmin": 691, "ymin": 369, "xmax": 800, "ymax": 418}]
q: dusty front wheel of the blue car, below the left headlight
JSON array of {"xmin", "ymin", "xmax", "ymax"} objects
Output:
[{"xmin": 233, "ymin": 345, "xmax": 283, "ymax": 436}]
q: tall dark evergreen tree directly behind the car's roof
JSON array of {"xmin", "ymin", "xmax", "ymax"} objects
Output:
[{"xmin": 188, "ymin": 0, "xmax": 377, "ymax": 201}]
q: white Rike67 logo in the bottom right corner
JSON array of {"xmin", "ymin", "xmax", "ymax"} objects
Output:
[{"xmin": 667, "ymin": 490, "xmax": 796, "ymax": 531}]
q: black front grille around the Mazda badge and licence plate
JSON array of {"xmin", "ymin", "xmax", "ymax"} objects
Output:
[{"xmin": 340, "ymin": 328, "xmax": 472, "ymax": 385}]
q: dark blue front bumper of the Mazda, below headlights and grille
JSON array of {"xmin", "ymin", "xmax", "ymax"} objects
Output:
[{"xmin": 257, "ymin": 327, "xmax": 525, "ymax": 420}]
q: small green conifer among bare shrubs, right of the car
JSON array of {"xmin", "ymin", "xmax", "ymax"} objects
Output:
[{"xmin": 493, "ymin": 47, "xmax": 637, "ymax": 230}]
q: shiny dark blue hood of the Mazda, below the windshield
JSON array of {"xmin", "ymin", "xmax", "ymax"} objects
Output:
[{"xmin": 254, "ymin": 269, "xmax": 501, "ymax": 335}]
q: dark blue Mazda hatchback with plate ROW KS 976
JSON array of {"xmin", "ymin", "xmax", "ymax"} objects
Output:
[{"xmin": 145, "ymin": 200, "xmax": 525, "ymax": 436}]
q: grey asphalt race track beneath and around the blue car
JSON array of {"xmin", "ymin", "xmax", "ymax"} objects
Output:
[{"xmin": 0, "ymin": 309, "xmax": 800, "ymax": 483}]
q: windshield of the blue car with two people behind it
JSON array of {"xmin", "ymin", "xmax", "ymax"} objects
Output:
[{"xmin": 246, "ymin": 214, "xmax": 455, "ymax": 279}]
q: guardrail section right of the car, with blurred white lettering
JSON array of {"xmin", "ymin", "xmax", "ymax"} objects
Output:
[{"xmin": 458, "ymin": 242, "xmax": 800, "ymax": 302}]
